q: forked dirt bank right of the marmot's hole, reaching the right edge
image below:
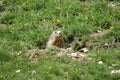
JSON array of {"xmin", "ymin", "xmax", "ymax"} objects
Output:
[{"xmin": 72, "ymin": 29, "xmax": 120, "ymax": 51}]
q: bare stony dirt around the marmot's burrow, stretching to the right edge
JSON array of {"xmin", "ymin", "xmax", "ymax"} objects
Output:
[{"xmin": 22, "ymin": 29, "xmax": 120, "ymax": 61}]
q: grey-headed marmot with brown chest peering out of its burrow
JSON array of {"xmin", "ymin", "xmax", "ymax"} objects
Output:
[{"xmin": 46, "ymin": 30, "xmax": 64, "ymax": 48}]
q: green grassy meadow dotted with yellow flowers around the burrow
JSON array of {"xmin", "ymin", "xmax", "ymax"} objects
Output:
[{"xmin": 0, "ymin": 0, "xmax": 120, "ymax": 80}]
